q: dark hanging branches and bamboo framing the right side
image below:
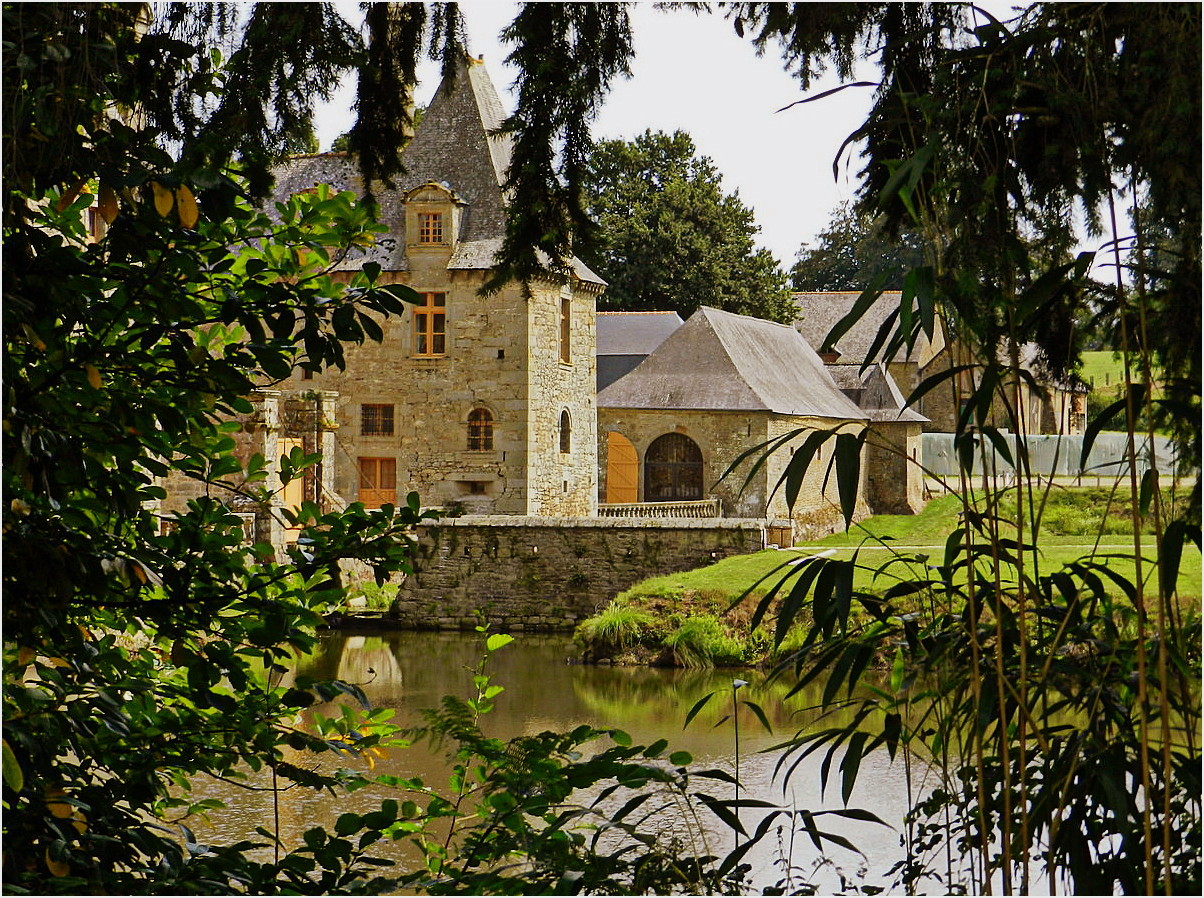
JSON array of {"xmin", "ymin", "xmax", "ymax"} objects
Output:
[{"xmin": 703, "ymin": 4, "xmax": 1200, "ymax": 894}]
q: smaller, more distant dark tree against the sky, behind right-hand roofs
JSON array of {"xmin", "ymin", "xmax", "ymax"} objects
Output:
[{"xmin": 790, "ymin": 202, "xmax": 925, "ymax": 293}]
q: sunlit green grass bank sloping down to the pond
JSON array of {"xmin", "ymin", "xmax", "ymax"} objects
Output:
[{"xmin": 577, "ymin": 489, "xmax": 1202, "ymax": 667}]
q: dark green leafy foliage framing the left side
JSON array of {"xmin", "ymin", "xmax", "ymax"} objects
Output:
[{"xmin": 4, "ymin": 4, "xmax": 425, "ymax": 894}]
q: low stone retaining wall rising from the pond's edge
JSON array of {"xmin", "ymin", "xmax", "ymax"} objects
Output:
[{"xmin": 395, "ymin": 515, "xmax": 765, "ymax": 631}]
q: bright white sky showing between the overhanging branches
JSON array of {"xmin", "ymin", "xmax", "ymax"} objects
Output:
[{"xmin": 318, "ymin": 0, "xmax": 1030, "ymax": 268}]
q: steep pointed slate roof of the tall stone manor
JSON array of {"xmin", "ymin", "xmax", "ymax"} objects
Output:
[{"xmin": 264, "ymin": 58, "xmax": 606, "ymax": 284}]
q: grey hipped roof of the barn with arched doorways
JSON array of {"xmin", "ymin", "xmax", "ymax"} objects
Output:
[{"xmin": 597, "ymin": 306, "xmax": 866, "ymax": 420}]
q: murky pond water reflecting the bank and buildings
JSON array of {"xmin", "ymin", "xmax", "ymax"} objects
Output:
[{"xmin": 197, "ymin": 633, "xmax": 907, "ymax": 891}]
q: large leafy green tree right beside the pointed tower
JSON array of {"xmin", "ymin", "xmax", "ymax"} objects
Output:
[{"xmin": 583, "ymin": 131, "xmax": 793, "ymax": 321}]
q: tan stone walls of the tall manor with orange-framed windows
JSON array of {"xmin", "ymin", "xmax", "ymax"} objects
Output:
[{"xmin": 281, "ymin": 263, "xmax": 597, "ymax": 515}]
